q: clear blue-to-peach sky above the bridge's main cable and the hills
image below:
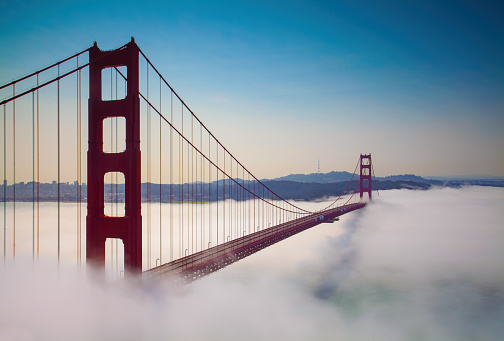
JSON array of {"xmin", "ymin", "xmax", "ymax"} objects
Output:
[{"xmin": 0, "ymin": 0, "xmax": 504, "ymax": 178}]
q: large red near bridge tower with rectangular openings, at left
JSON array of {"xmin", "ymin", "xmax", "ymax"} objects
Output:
[{"xmin": 86, "ymin": 38, "xmax": 142, "ymax": 274}]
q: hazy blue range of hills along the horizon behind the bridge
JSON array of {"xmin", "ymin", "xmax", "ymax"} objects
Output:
[{"xmin": 0, "ymin": 172, "xmax": 504, "ymax": 202}]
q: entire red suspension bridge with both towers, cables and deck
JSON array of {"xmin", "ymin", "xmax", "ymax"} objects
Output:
[{"xmin": 0, "ymin": 39, "xmax": 373, "ymax": 282}]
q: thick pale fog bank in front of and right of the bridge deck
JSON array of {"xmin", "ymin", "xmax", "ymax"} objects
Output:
[{"xmin": 0, "ymin": 187, "xmax": 504, "ymax": 340}]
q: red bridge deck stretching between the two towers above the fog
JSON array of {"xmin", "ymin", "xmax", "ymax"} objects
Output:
[{"xmin": 142, "ymin": 203, "xmax": 366, "ymax": 285}]
